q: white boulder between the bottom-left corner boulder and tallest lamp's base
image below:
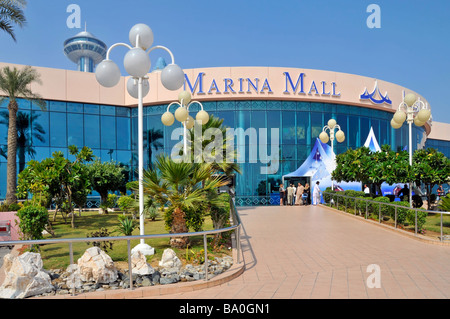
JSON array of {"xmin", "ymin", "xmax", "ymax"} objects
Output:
[{"xmin": 78, "ymin": 247, "xmax": 118, "ymax": 284}]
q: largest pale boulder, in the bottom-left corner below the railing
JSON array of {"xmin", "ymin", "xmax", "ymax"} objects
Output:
[{"xmin": 0, "ymin": 252, "xmax": 54, "ymax": 299}]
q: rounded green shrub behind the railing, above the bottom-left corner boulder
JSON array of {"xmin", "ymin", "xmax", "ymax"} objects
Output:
[{"xmin": 16, "ymin": 205, "xmax": 48, "ymax": 240}]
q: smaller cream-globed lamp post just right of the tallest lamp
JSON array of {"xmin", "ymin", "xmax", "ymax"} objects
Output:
[{"xmin": 161, "ymin": 91, "xmax": 209, "ymax": 160}]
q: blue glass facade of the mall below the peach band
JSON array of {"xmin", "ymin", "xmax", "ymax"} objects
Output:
[{"xmin": 0, "ymin": 100, "xmax": 425, "ymax": 205}]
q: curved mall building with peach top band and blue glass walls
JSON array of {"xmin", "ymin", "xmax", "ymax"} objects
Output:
[{"xmin": 0, "ymin": 63, "xmax": 444, "ymax": 205}]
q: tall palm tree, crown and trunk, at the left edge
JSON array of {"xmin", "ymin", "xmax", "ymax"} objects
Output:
[{"xmin": 0, "ymin": 66, "xmax": 46, "ymax": 204}]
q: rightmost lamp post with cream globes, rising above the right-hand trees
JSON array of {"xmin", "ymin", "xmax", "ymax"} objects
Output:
[{"xmin": 391, "ymin": 93, "xmax": 431, "ymax": 207}]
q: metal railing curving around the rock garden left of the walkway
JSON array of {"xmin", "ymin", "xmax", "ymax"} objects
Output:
[{"xmin": 0, "ymin": 199, "xmax": 242, "ymax": 295}]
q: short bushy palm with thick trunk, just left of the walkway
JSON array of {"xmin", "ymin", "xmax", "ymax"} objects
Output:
[{"xmin": 143, "ymin": 155, "xmax": 224, "ymax": 248}]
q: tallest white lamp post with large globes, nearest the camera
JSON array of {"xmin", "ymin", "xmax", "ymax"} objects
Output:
[{"xmin": 95, "ymin": 23, "xmax": 184, "ymax": 255}]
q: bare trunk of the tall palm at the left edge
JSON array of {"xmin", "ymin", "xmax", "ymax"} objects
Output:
[{"xmin": 5, "ymin": 100, "xmax": 18, "ymax": 205}]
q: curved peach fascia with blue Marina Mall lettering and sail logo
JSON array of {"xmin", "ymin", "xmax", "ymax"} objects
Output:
[{"xmin": 176, "ymin": 67, "xmax": 423, "ymax": 109}]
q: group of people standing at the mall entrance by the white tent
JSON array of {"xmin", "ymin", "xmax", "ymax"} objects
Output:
[{"xmin": 280, "ymin": 182, "xmax": 320, "ymax": 206}]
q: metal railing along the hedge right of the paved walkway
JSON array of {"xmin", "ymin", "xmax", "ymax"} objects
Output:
[{"xmin": 323, "ymin": 192, "xmax": 450, "ymax": 242}]
